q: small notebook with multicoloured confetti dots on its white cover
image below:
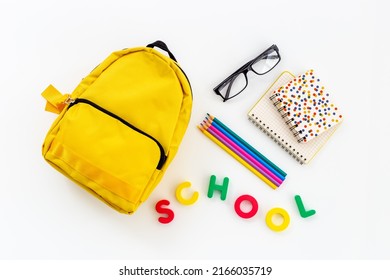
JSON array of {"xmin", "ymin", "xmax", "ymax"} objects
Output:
[{"xmin": 270, "ymin": 70, "xmax": 342, "ymax": 143}]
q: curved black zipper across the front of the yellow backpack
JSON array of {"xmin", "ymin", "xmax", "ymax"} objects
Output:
[{"xmin": 68, "ymin": 98, "xmax": 167, "ymax": 170}]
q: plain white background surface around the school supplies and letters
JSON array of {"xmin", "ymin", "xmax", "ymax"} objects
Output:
[{"xmin": 0, "ymin": 0, "xmax": 390, "ymax": 260}]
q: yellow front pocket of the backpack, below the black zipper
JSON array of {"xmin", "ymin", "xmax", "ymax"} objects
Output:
[{"xmin": 45, "ymin": 99, "xmax": 166, "ymax": 212}]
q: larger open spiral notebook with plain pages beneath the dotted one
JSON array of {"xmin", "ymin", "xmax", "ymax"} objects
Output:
[{"xmin": 248, "ymin": 71, "xmax": 338, "ymax": 164}]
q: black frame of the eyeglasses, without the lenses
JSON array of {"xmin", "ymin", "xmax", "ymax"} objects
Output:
[{"xmin": 214, "ymin": 45, "xmax": 282, "ymax": 102}]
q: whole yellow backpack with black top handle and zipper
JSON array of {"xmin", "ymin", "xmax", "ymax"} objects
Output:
[{"xmin": 42, "ymin": 41, "xmax": 192, "ymax": 214}]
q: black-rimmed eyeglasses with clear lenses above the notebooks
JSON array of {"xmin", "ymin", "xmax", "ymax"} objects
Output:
[{"xmin": 214, "ymin": 45, "xmax": 281, "ymax": 102}]
